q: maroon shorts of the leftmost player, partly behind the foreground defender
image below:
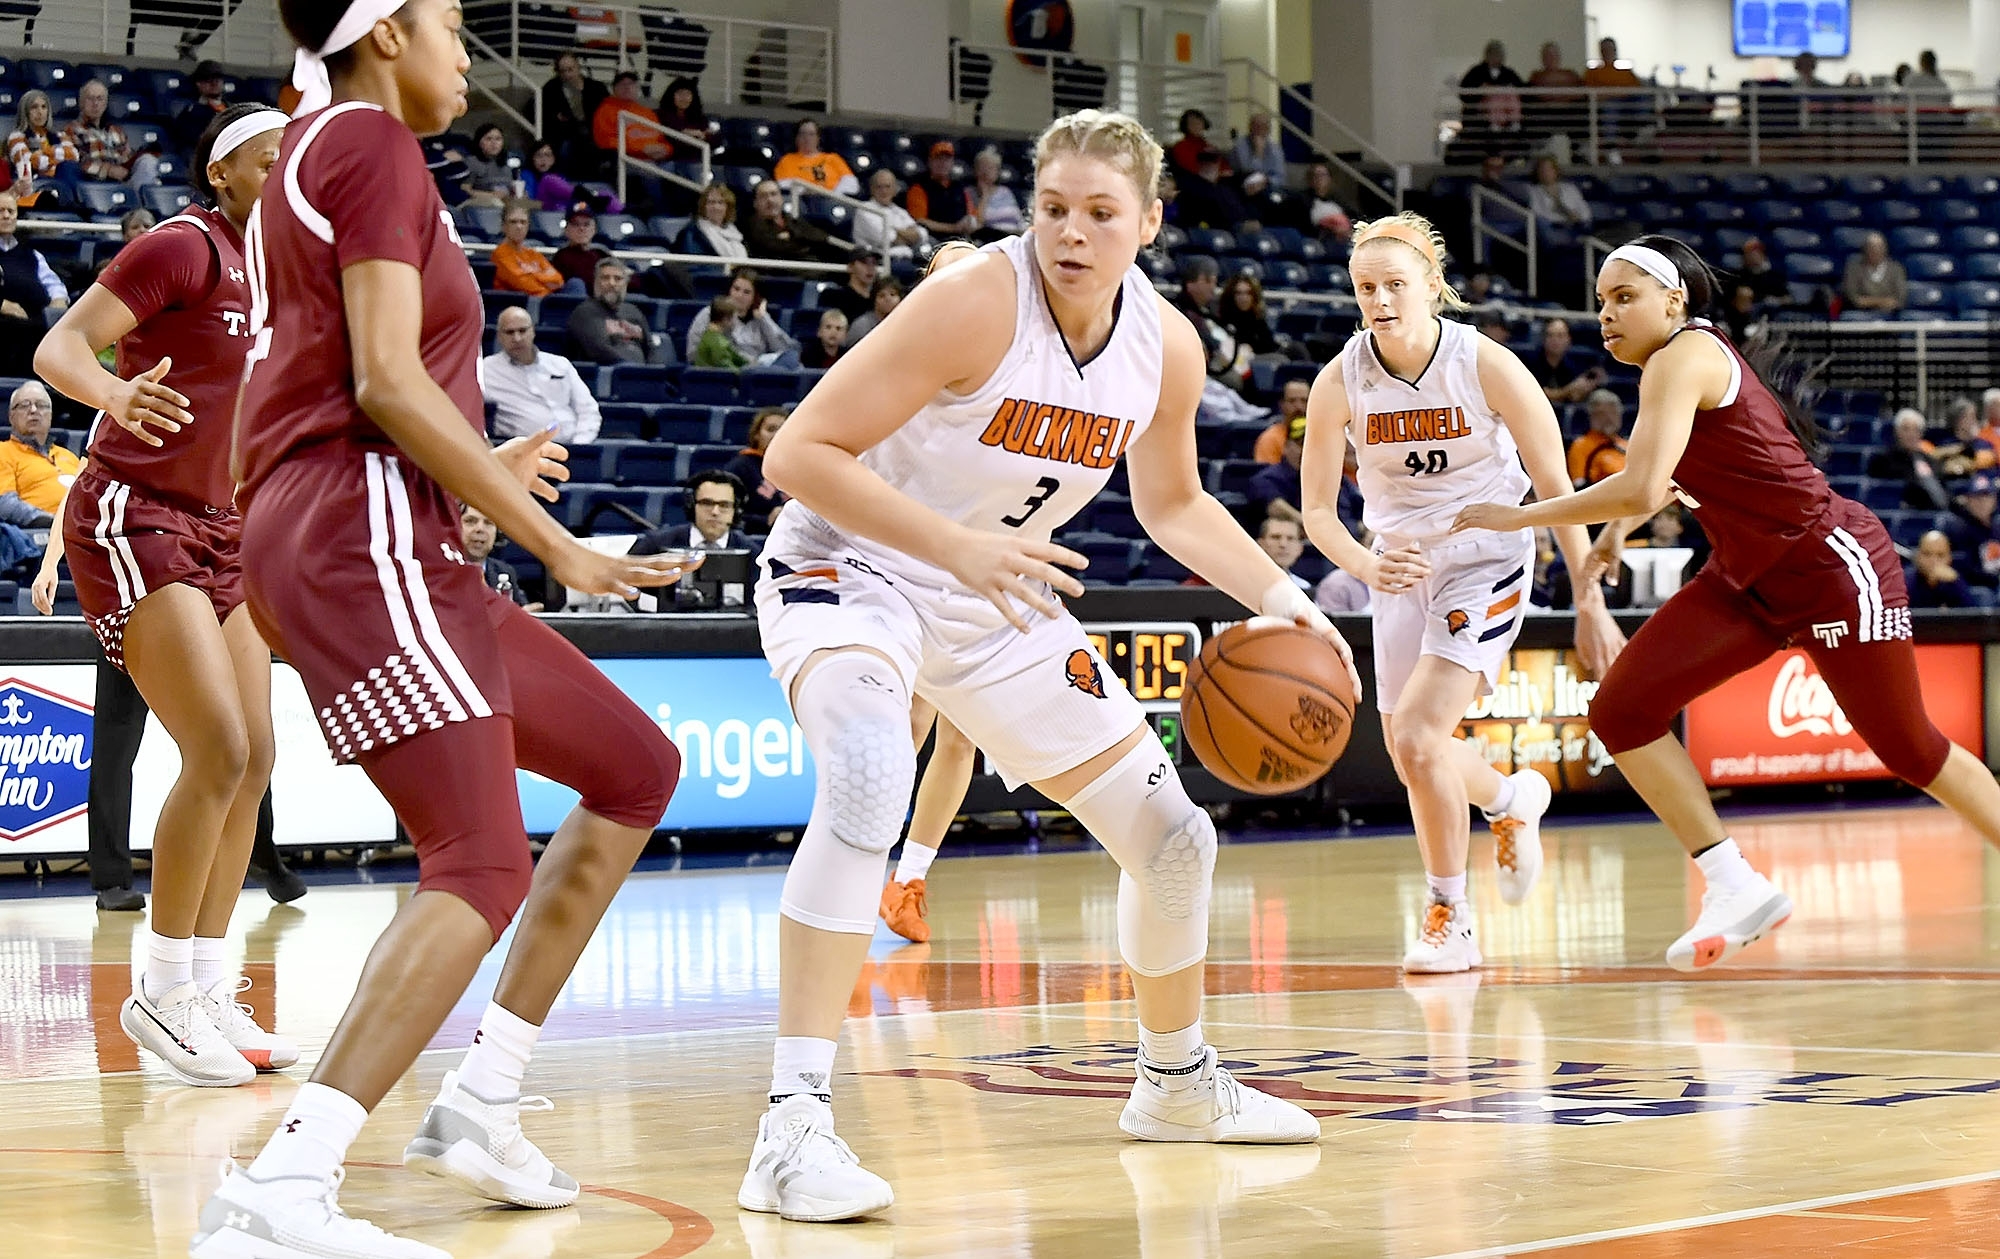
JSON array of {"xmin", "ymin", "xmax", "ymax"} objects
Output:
[{"xmin": 62, "ymin": 462, "xmax": 244, "ymax": 669}]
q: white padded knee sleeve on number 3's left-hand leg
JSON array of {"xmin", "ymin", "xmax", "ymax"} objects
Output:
[{"xmin": 778, "ymin": 651, "xmax": 916, "ymax": 935}]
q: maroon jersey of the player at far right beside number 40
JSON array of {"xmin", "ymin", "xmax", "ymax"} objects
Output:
[{"xmin": 1674, "ymin": 322, "xmax": 1836, "ymax": 590}]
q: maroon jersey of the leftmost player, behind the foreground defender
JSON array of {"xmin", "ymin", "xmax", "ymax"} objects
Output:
[{"xmin": 90, "ymin": 206, "xmax": 250, "ymax": 508}]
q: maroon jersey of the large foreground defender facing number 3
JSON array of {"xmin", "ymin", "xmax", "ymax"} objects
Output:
[{"xmin": 236, "ymin": 100, "xmax": 486, "ymax": 504}]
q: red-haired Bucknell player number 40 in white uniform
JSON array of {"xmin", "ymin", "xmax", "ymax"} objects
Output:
[{"xmin": 1300, "ymin": 214, "xmax": 1624, "ymax": 973}]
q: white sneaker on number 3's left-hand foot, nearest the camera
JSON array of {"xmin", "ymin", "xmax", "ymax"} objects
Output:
[{"xmin": 736, "ymin": 1093, "xmax": 896, "ymax": 1223}]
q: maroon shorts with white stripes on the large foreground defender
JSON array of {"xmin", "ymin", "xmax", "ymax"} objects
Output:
[{"xmin": 242, "ymin": 442, "xmax": 514, "ymax": 763}]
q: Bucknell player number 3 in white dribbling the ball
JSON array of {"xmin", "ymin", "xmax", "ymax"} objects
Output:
[{"xmin": 736, "ymin": 110, "xmax": 1358, "ymax": 1221}]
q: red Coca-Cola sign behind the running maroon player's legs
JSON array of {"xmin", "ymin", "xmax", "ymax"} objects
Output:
[{"xmin": 1688, "ymin": 643, "xmax": 1986, "ymax": 785}]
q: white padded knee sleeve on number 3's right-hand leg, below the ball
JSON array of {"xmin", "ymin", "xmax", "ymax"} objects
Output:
[{"xmin": 1064, "ymin": 731, "xmax": 1216, "ymax": 975}]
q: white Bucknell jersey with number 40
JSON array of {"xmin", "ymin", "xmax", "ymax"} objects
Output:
[{"xmin": 1342, "ymin": 320, "xmax": 1530, "ymax": 540}]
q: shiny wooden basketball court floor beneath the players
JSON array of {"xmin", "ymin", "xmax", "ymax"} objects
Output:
[{"xmin": 0, "ymin": 807, "xmax": 2000, "ymax": 1259}]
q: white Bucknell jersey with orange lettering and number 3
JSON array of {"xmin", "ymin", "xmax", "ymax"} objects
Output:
[{"xmin": 770, "ymin": 234, "xmax": 1164, "ymax": 586}]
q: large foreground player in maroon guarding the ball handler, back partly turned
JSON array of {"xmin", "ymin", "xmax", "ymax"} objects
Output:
[{"xmin": 190, "ymin": 0, "xmax": 688, "ymax": 1259}]
